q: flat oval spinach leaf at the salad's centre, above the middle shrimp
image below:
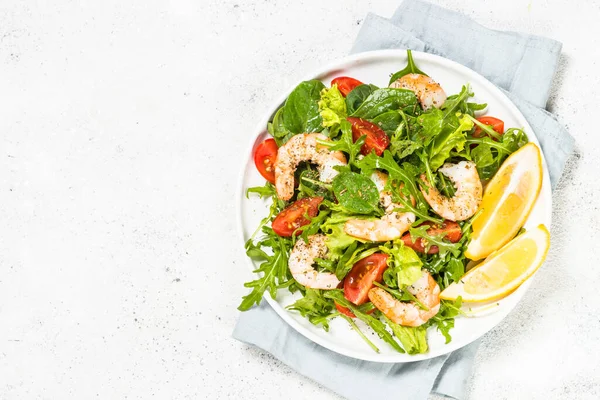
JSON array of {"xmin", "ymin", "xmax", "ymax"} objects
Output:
[{"xmin": 332, "ymin": 172, "xmax": 381, "ymax": 214}]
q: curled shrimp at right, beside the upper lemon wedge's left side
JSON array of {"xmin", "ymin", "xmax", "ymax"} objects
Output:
[{"xmin": 421, "ymin": 161, "xmax": 483, "ymax": 221}]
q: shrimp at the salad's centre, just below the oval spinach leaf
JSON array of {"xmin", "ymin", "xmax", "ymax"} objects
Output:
[{"xmin": 344, "ymin": 171, "xmax": 415, "ymax": 242}]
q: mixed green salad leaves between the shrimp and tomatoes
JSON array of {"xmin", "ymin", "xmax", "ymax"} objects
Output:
[{"xmin": 239, "ymin": 51, "xmax": 527, "ymax": 354}]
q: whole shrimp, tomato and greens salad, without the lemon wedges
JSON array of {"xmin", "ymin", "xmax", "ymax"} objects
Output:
[{"xmin": 239, "ymin": 50, "xmax": 527, "ymax": 354}]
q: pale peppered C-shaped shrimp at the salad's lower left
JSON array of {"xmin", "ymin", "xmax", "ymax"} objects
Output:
[{"xmin": 288, "ymin": 233, "xmax": 340, "ymax": 289}]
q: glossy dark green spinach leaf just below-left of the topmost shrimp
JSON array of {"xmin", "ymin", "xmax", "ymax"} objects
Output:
[{"xmin": 352, "ymin": 88, "xmax": 418, "ymax": 120}]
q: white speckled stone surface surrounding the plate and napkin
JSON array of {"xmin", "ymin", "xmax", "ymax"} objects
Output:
[{"xmin": 0, "ymin": 0, "xmax": 600, "ymax": 400}]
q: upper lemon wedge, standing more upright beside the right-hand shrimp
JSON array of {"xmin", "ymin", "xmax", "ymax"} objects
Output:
[{"xmin": 465, "ymin": 143, "xmax": 542, "ymax": 260}]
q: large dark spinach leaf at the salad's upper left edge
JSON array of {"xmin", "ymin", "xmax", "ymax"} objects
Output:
[{"xmin": 283, "ymin": 80, "xmax": 325, "ymax": 133}]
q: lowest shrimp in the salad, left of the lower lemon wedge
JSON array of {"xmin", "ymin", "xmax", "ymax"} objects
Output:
[{"xmin": 369, "ymin": 271, "xmax": 440, "ymax": 326}]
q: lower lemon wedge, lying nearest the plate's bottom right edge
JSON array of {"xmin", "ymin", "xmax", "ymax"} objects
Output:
[{"xmin": 440, "ymin": 225, "xmax": 550, "ymax": 302}]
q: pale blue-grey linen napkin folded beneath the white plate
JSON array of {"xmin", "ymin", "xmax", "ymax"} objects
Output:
[{"xmin": 233, "ymin": 0, "xmax": 574, "ymax": 400}]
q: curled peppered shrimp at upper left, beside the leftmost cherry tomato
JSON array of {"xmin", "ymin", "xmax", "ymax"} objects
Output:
[{"xmin": 275, "ymin": 133, "xmax": 346, "ymax": 200}]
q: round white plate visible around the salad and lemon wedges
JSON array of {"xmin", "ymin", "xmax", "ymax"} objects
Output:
[{"xmin": 237, "ymin": 50, "xmax": 552, "ymax": 362}]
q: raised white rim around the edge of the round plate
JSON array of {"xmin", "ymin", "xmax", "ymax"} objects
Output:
[{"xmin": 235, "ymin": 49, "xmax": 552, "ymax": 363}]
